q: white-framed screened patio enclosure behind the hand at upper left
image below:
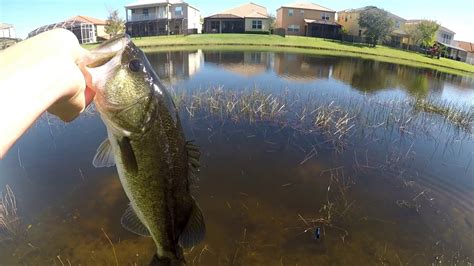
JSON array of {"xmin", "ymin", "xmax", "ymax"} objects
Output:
[{"xmin": 28, "ymin": 20, "xmax": 97, "ymax": 44}]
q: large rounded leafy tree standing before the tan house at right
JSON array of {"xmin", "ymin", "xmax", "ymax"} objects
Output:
[{"xmin": 359, "ymin": 8, "xmax": 394, "ymax": 47}]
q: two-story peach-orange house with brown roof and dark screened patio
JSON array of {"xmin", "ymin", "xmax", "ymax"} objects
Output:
[{"xmin": 276, "ymin": 3, "xmax": 341, "ymax": 38}]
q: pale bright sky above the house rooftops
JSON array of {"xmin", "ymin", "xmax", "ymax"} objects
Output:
[{"xmin": 0, "ymin": 0, "xmax": 474, "ymax": 43}]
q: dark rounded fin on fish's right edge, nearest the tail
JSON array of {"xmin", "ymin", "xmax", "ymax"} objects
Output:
[{"xmin": 179, "ymin": 198, "xmax": 206, "ymax": 248}]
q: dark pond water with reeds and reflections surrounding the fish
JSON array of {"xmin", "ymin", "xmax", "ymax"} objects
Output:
[{"xmin": 0, "ymin": 50, "xmax": 474, "ymax": 265}]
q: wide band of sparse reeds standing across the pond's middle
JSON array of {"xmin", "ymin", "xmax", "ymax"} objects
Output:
[{"xmin": 172, "ymin": 86, "xmax": 472, "ymax": 156}]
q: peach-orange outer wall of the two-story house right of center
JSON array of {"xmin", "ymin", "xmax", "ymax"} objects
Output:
[{"xmin": 277, "ymin": 7, "xmax": 336, "ymax": 36}]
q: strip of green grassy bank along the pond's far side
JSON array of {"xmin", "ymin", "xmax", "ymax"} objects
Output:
[{"xmin": 83, "ymin": 34, "xmax": 474, "ymax": 75}]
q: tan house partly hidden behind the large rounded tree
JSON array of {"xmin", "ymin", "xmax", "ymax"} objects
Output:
[{"xmin": 337, "ymin": 6, "xmax": 407, "ymax": 47}]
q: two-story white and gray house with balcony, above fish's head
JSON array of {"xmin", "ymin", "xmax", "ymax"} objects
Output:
[{"xmin": 125, "ymin": 0, "xmax": 202, "ymax": 36}]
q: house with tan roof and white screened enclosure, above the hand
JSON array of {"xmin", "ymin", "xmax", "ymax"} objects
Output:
[{"xmin": 28, "ymin": 16, "xmax": 105, "ymax": 44}]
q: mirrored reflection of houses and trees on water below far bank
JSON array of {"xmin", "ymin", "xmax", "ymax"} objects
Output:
[{"xmin": 148, "ymin": 50, "xmax": 474, "ymax": 99}]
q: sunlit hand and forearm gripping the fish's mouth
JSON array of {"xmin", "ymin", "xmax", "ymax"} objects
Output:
[{"xmin": 0, "ymin": 29, "xmax": 94, "ymax": 159}]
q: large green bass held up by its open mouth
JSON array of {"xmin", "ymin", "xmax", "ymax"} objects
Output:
[{"xmin": 87, "ymin": 35, "xmax": 206, "ymax": 265}]
